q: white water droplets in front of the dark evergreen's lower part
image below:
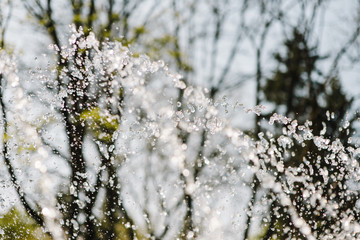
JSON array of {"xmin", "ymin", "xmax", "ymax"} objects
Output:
[{"xmin": 253, "ymin": 114, "xmax": 360, "ymax": 239}]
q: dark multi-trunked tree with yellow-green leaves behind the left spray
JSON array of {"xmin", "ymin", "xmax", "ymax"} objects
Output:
[{"xmin": 1, "ymin": 0, "xmax": 151, "ymax": 239}]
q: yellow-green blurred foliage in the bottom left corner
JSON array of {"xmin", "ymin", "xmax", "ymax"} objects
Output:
[{"xmin": 0, "ymin": 208, "xmax": 49, "ymax": 240}]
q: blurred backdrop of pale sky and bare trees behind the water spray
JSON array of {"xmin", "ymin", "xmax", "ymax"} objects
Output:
[{"xmin": 0, "ymin": 0, "xmax": 360, "ymax": 239}]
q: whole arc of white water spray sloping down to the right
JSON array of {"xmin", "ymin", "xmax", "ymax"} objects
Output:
[{"xmin": 0, "ymin": 26, "xmax": 360, "ymax": 239}]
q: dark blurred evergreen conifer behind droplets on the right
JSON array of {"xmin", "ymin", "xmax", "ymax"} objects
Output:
[{"xmin": 263, "ymin": 28, "xmax": 359, "ymax": 239}]
